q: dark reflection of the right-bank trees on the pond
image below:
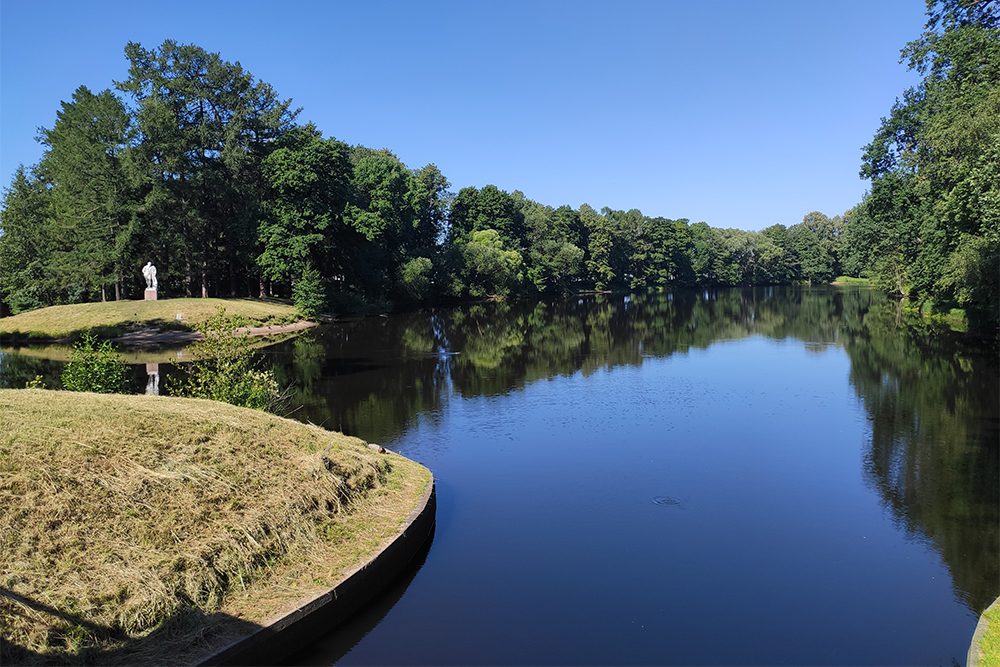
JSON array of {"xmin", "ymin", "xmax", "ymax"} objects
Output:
[{"xmin": 845, "ymin": 302, "xmax": 1000, "ymax": 613}]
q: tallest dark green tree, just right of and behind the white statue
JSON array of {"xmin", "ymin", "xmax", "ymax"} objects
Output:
[{"xmin": 117, "ymin": 40, "xmax": 298, "ymax": 295}]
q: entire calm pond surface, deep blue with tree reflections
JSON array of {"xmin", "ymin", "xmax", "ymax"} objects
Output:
[{"xmin": 0, "ymin": 287, "xmax": 1000, "ymax": 665}]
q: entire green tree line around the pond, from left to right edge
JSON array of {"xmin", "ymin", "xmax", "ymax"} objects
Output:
[{"xmin": 0, "ymin": 0, "xmax": 1000, "ymax": 324}]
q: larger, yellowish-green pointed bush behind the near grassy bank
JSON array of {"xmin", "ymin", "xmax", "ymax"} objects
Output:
[{"xmin": 168, "ymin": 306, "xmax": 281, "ymax": 412}]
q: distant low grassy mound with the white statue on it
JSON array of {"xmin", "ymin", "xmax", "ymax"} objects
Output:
[{"xmin": 0, "ymin": 298, "xmax": 302, "ymax": 339}]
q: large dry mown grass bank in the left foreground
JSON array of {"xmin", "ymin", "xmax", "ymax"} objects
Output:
[{"xmin": 0, "ymin": 390, "xmax": 430, "ymax": 664}]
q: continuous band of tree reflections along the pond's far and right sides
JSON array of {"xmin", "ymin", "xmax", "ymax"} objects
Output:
[{"xmin": 268, "ymin": 287, "xmax": 1000, "ymax": 611}]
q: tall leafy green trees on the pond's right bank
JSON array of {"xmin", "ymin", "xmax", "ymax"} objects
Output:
[{"xmin": 845, "ymin": 0, "xmax": 1000, "ymax": 320}]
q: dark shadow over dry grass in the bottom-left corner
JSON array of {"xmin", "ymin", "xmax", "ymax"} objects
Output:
[{"xmin": 0, "ymin": 587, "xmax": 260, "ymax": 667}]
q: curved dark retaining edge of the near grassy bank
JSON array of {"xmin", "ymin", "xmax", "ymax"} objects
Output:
[{"xmin": 198, "ymin": 478, "xmax": 437, "ymax": 667}]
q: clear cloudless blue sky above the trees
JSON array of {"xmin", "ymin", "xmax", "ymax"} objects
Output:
[{"xmin": 0, "ymin": 0, "xmax": 925, "ymax": 230}]
